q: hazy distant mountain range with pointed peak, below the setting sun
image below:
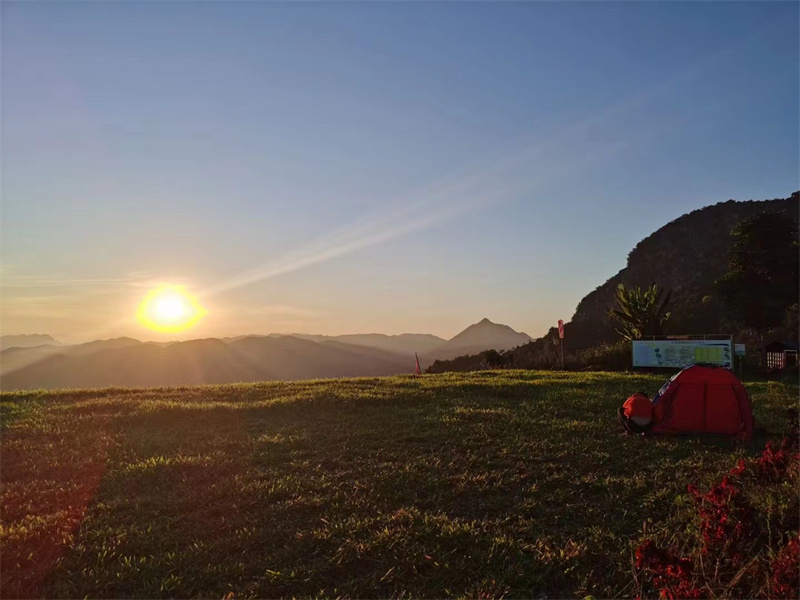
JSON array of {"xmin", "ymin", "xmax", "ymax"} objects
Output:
[{"xmin": 0, "ymin": 319, "xmax": 531, "ymax": 391}]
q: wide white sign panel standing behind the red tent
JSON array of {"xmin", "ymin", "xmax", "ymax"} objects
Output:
[{"xmin": 633, "ymin": 340, "xmax": 733, "ymax": 369}]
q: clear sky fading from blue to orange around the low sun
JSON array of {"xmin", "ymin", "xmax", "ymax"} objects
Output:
[{"xmin": 0, "ymin": 1, "xmax": 800, "ymax": 343}]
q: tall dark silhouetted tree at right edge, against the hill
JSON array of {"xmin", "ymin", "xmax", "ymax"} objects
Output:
[{"xmin": 714, "ymin": 212, "xmax": 800, "ymax": 369}]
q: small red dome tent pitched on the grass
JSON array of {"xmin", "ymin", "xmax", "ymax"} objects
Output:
[{"xmin": 651, "ymin": 365, "xmax": 753, "ymax": 440}]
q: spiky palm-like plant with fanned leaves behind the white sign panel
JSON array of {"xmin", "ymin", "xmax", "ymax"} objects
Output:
[{"xmin": 608, "ymin": 283, "xmax": 672, "ymax": 340}]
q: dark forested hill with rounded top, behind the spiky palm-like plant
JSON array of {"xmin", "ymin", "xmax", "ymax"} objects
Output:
[{"xmin": 566, "ymin": 192, "xmax": 800, "ymax": 350}]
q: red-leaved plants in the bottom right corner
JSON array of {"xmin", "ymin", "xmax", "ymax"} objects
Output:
[{"xmin": 636, "ymin": 411, "xmax": 800, "ymax": 600}]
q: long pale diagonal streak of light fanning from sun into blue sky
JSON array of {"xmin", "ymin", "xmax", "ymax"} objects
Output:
[{"xmin": 205, "ymin": 23, "xmax": 767, "ymax": 295}]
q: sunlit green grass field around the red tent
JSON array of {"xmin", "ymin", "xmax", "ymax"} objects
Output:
[{"xmin": 0, "ymin": 371, "xmax": 798, "ymax": 598}]
